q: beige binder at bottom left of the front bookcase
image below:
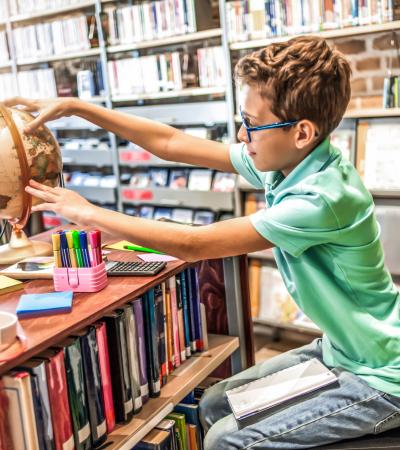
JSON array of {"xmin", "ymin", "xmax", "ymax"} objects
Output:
[{"xmin": 3, "ymin": 371, "xmax": 40, "ymax": 450}]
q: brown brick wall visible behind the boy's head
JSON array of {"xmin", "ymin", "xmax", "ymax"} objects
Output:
[{"xmin": 331, "ymin": 32, "xmax": 400, "ymax": 108}]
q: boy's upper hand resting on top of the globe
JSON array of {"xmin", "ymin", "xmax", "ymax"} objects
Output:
[{"xmin": 3, "ymin": 97, "xmax": 78, "ymax": 133}]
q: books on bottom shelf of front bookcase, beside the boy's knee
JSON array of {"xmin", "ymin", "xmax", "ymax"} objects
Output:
[{"xmin": 133, "ymin": 385, "xmax": 205, "ymax": 450}]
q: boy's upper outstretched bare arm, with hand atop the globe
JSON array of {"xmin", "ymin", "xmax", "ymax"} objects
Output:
[{"xmin": 4, "ymin": 97, "xmax": 236, "ymax": 173}]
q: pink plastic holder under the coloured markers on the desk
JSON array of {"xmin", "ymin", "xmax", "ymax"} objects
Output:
[{"xmin": 53, "ymin": 262, "xmax": 108, "ymax": 292}]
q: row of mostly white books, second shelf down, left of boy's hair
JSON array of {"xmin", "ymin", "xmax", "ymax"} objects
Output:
[{"xmin": 108, "ymin": 47, "xmax": 226, "ymax": 96}]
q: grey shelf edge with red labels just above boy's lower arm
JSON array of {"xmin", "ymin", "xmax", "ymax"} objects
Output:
[{"xmin": 119, "ymin": 185, "xmax": 233, "ymax": 211}]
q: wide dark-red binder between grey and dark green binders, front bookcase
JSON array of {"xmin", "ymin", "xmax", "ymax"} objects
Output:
[{"xmin": 39, "ymin": 349, "xmax": 75, "ymax": 450}]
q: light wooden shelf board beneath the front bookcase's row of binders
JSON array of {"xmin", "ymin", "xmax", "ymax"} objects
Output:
[{"xmin": 105, "ymin": 334, "xmax": 239, "ymax": 450}]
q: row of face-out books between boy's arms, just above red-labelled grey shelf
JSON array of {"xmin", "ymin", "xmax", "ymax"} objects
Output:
[{"xmin": 121, "ymin": 168, "xmax": 236, "ymax": 192}]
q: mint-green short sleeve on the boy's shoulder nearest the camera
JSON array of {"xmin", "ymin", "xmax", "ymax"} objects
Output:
[{"xmin": 250, "ymin": 193, "xmax": 339, "ymax": 257}]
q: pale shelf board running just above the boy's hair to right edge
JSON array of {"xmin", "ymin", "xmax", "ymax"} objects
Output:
[{"xmin": 230, "ymin": 20, "xmax": 400, "ymax": 50}]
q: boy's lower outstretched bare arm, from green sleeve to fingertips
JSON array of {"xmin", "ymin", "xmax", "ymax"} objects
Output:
[{"xmin": 26, "ymin": 181, "xmax": 273, "ymax": 262}]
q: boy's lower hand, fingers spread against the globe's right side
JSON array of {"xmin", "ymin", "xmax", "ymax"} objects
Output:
[{"xmin": 25, "ymin": 180, "xmax": 99, "ymax": 225}]
